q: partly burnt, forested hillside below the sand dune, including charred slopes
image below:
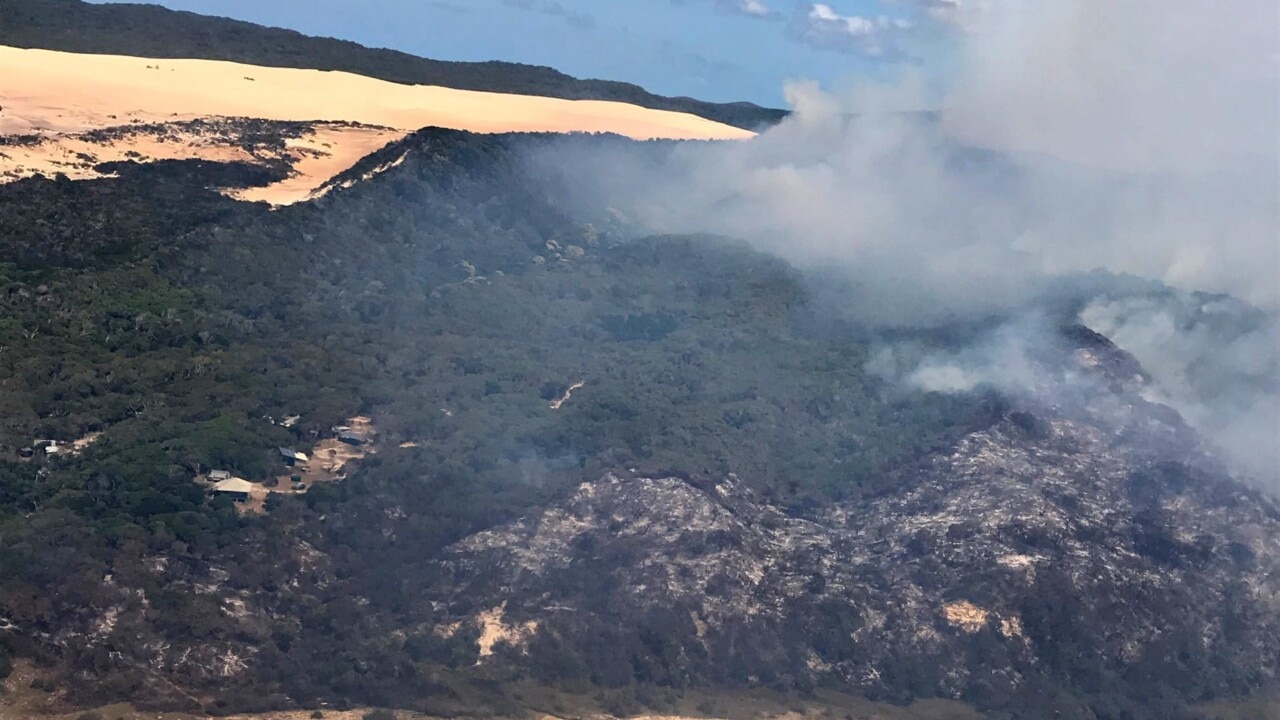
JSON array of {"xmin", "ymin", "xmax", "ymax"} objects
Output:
[{"xmin": 0, "ymin": 129, "xmax": 1280, "ymax": 717}]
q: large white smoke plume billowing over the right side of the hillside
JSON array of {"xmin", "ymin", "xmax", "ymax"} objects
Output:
[{"xmin": 535, "ymin": 0, "xmax": 1280, "ymax": 481}]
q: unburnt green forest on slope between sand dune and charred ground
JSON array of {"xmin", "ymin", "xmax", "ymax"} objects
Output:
[{"xmin": 0, "ymin": 131, "xmax": 988, "ymax": 502}]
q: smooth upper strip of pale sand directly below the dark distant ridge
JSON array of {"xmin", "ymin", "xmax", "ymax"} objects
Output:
[{"xmin": 0, "ymin": 46, "xmax": 753, "ymax": 140}]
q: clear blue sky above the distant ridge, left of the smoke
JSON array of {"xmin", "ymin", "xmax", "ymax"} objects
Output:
[{"xmin": 82, "ymin": 0, "xmax": 957, "ymax": 106}]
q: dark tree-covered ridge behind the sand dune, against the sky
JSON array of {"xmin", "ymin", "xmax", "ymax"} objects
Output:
[{"xmin": 0, "ymin": 0, "xmax": 786, "ymax": 129}]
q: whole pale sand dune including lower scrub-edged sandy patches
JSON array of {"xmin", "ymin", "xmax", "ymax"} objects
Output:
[{"xmin": 0, "ymin": 46, "xmax": 753, "ymax": 204}]
